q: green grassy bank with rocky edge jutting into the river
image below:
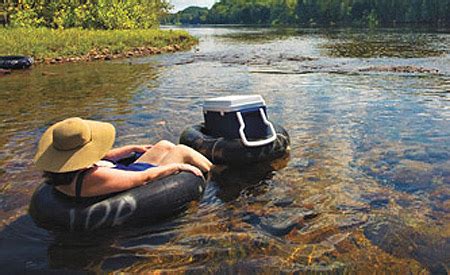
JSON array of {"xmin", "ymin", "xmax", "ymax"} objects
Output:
[{"xmin": 0, "ymin": 28, "xmax": 197, "ymax": 63}]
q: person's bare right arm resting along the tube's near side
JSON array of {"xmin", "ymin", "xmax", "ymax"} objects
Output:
[{"xmin": 81, "ymin": 163, "xmax": 202, "ymax": 197}]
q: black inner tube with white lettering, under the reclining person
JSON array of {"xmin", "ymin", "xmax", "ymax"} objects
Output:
[{"xmin": 29, "ymin": 172, "xmax": 205, "ymax": 232}]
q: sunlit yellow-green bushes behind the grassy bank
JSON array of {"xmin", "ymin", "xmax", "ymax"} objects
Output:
[{"xmin": 0, "ymin": 0, "xmax": 170, "ymax": 29}]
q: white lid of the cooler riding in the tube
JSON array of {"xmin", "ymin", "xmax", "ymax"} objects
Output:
[{"xmin": 203, "ymin": 95, "xmax": 266, "ymax": 112}]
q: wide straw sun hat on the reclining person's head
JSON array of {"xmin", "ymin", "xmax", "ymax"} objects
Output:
[{"xmin": 34, "ymin": 117, "xmax": 116, "ymax": 173}]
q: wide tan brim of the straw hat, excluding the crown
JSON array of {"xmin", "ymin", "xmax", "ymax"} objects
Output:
[{"xmin": 34, "ymin": 120, "xmax": 116, "ymax": 173}]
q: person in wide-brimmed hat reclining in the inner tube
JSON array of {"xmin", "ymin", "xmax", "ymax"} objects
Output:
[{"xmin": 34, "ymin": 117, "xmax": 212, "ymax": 200}]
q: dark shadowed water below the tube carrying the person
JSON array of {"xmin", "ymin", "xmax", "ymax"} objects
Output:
[{"xmin": 0, "ymin": 215, "xmax": 184, "ymax": 273}]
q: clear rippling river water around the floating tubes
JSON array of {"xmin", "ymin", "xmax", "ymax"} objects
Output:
[{"xmin": 0, "ymin": 28, "xmax": 450, "ymax": 274}]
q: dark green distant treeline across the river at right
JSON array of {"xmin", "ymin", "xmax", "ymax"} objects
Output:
[{"xmin": 163, "ymin": 0, "xmax": 450, "ymax": 26}]
